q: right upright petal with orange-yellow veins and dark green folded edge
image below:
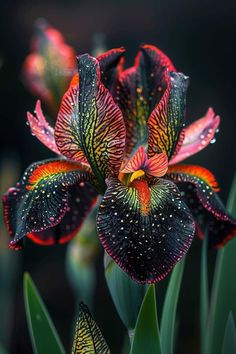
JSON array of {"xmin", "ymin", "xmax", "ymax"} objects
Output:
[{"xmin": 148, "ymin": 72, "xmax": 188, "ymax": 159}]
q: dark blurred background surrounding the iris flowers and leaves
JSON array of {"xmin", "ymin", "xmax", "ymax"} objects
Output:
[{"xmin": 0, "ymin": 0, "xmax": 236, "ymax": 354}]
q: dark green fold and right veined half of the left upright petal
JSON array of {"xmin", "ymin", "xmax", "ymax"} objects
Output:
[{"xmin": 78, "ymin": 54, "xmax": 125, "ymax": 184}]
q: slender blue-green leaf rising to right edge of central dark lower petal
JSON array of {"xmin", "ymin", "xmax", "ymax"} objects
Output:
[{"xmin": 161, "ymin": 258, "xmax": 185, "ymax": 354}]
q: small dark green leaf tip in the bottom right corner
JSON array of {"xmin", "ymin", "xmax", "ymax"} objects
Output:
[{"xmin": 222, "ymin": 312, "xmax": 236, "ymax": 354}]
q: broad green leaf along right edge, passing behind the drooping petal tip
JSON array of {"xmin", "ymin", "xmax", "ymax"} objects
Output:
[{"xmin": 207, "ymin": 176, "xmax": 236, "ymax": 354}]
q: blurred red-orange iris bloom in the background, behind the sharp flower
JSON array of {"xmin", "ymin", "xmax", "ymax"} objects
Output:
[{"xmin": 22, "ymin": 19, "xmax": 76, "ymax": 113}]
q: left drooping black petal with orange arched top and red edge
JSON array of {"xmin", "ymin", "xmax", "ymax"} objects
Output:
[{"xmin": 3, "ymin": 159, "xmax": 97, "ymax": 248}]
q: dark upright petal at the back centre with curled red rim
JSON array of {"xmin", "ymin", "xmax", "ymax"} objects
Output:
[{"xmin": 116, "ymin": 45, "xmax": 175, "ymax": 155}]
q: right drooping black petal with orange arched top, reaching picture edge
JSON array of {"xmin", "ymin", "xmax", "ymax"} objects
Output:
[{"xmin": 167, "ymin": 165, "xmax": 236, "ymax": 247}]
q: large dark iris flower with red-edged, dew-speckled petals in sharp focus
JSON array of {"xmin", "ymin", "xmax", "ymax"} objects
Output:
[{"xmin": 4, "ymin": 45, "xmax": 236, "ymax": 283}]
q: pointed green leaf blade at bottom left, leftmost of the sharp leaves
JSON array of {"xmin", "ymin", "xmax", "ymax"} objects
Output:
[{"xmin": 24, "ymin": 273, "xmax": 65, "ymax": 354}]
